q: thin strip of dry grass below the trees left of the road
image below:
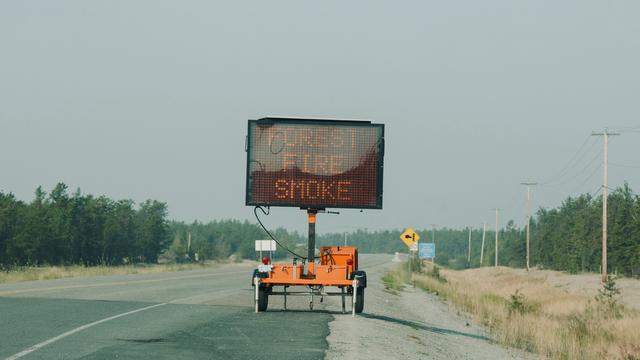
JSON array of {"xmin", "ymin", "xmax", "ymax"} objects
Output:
[{"xmin": 0, "ymin": 262, "xmax": 226, "ymax": 284}]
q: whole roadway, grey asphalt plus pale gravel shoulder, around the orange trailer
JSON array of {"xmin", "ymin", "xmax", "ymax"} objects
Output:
[{"xmin": 0, "ymin": 255, "xmax": 528, "ymax": 360}]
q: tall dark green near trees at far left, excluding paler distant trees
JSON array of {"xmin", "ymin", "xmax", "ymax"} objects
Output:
[{"xmin": 0, "ymin": 183, "xmax": 170, "ymax": 268}]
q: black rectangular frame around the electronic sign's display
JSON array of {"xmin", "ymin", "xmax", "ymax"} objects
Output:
[{"xmin": 245, "ymin": 117, "xmax": 385, "ymax": 210}]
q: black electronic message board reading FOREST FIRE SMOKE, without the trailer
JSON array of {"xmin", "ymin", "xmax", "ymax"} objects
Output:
[{"xmin": 246, "ymin": 118, "xmax": 384, "ymax": 209}]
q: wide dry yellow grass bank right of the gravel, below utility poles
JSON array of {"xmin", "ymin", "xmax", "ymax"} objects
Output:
[{"xmin": 414, "ymin": 262, "xmax": 640, "ymax": 360}]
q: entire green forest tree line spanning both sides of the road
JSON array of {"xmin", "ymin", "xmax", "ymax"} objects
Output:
[{"xmin": 0, "ymin": 183, "xmax": 640, "ymax": 276}]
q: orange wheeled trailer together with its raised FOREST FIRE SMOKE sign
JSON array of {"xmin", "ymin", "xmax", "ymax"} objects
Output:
[{"xmin": 245, "ymin": 117, "xmax": 384, "ymax": 315}]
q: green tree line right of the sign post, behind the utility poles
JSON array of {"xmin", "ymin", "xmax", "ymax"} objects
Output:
[{"xmin": 319, "ymin": 184, "xmax": 640, "ymax": 276}]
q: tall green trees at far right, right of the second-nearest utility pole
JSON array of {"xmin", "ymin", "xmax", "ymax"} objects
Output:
[{"xmin": 532, "ymin": 184, "xmax": 640, "ymax": 276}]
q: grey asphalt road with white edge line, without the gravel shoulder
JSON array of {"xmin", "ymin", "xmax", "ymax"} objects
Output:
[{"xmin": 0, "ymin": 256, "xmax": 387, "ymax": 359}]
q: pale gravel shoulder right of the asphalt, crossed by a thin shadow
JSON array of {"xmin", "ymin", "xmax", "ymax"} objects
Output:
[{"xmin": 325, "ymin": 257, "xmax": 535, "ymax": 360}]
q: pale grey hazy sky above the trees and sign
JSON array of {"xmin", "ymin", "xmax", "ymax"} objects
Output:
[{"xmin": 0, "ymin": 0, "xmax": 640, "ymax": 232}]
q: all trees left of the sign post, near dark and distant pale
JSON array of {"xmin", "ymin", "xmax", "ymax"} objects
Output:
[{"xmin": 0, "ymin": 183, "xmax": 304, "ymax": 270}]
